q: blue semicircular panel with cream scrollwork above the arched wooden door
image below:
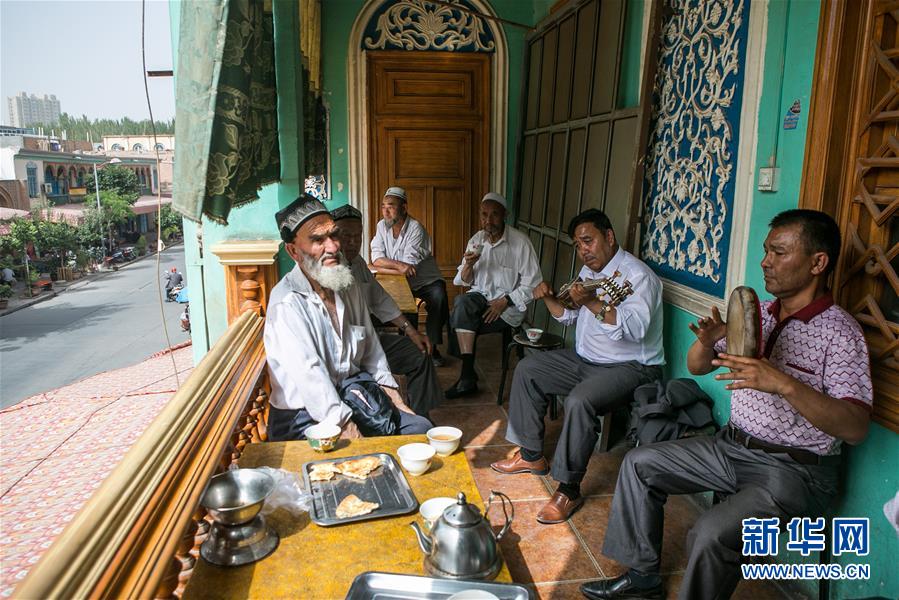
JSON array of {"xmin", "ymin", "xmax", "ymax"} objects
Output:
[{"xmin": 362, "ymin": 0, "xmax": 496, "ymax": 52}]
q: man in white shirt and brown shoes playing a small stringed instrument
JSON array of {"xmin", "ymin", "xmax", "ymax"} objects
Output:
[{"xmin": 491, "ymin": 209, "xmax": 665, "ymax": 523}]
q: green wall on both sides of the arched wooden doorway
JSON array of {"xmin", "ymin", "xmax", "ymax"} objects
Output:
[{"xmin": 322, "ymin": 0, "xmax": 556, "ymax": 208}]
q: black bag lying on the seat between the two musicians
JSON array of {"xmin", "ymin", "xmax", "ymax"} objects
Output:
[{"xmin": 627, "ymin": 379, "xmax": 715, "ymax": 445}]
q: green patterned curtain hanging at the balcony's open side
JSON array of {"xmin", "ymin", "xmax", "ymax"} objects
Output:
[{"xmin": 172, "ymin": 0, "xmax": 280, "ymax": 224}]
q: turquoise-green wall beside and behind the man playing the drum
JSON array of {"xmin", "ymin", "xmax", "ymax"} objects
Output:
[{"xmin": 665, "ymin": 0, "xmax": 899, "ymax": 598}]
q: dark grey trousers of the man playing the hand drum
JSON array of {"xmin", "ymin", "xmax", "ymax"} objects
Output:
[{"xmin": 602, "ymin": 430, "xmax": 837, "ymax": 599}]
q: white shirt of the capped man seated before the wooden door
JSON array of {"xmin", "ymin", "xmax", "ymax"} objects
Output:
[{"xmin": 371, "ymin": 216, "xmax": 443, "ymax": 290}]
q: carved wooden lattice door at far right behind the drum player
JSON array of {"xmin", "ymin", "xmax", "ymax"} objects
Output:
[{"xmin": 800, "ymin": 0, "xmax": 899, "ymax": 432}]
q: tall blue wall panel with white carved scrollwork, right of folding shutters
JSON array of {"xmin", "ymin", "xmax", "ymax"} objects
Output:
[{"xmin": 642, "ymin": 0, "xmax": 749, "ymax": 298}]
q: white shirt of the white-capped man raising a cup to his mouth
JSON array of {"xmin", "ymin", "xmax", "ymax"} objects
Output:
[{"xmin": 453, "ymin": 225, "xmax": 543, "ymax": 327}]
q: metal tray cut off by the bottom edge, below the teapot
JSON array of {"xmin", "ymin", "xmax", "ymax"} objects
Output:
[{"xmin": 346, "ymin": 571, "xmax": 534, "ymax": 600}]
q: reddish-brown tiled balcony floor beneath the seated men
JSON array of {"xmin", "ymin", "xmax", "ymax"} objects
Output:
[{"xmin": 431, "ymin": 336, "xmax": 803, "ymax": 600}]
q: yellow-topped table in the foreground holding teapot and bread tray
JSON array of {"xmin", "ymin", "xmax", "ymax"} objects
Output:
[{"xmin": 183, "ymin": 435, "xmax": 512, "ymax": 600}]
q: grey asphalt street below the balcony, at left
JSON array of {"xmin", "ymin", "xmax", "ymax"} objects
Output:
[{"xmin": 0, "ymin": 246, "xmax": 189, "ymax": 408}]
